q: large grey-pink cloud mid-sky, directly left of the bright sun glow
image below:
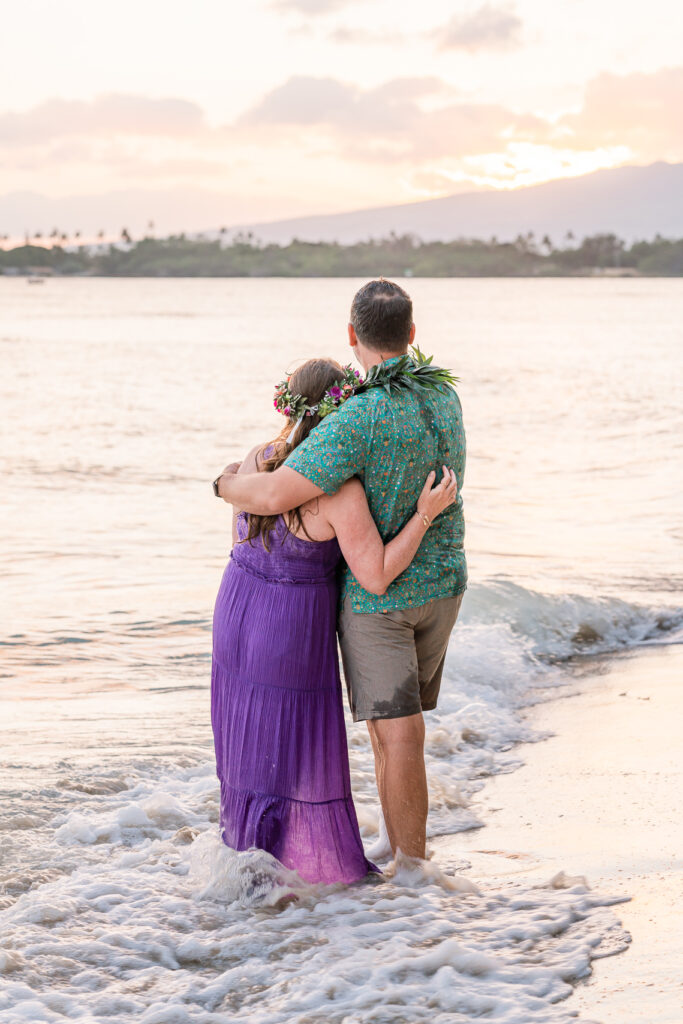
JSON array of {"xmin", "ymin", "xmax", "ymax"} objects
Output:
[{"xmin": 240, "ymin": 76, "xmax": 551, "ymax": 162}]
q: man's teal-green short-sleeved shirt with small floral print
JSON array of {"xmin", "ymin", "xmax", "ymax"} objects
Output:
[{"xmin": 286, "ymin": 359, "xmax": 467, "ymax": 612}]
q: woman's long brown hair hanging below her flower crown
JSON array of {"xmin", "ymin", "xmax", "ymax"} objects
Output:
[{"xmin": 241, "ymin": 359, "xmax": 344, "ymax": 551}]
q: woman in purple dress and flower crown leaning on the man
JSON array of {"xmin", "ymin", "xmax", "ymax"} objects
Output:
[{"xmin": 211, "ymin": 359, "xmax": 457, "ymax": 884}]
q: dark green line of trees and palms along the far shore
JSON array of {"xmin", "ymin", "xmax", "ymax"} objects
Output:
[{"xmin": 0, "ymin": 231, "xmax": 683, "ymax": 278}]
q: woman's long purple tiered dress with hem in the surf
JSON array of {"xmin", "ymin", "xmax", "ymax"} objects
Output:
[{"xmin": 211, "ymin": 515, "xmax": 376, "ymax": 884}]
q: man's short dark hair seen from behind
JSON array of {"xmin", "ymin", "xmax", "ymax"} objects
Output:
[{"xmin": 351, "ymin": 278, "xmax": 413, "ymax": 352}]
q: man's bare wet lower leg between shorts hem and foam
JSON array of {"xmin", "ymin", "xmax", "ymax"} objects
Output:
[{"xmin": 368, "ymin": 713, "xmax": 429, "ymax": 859}]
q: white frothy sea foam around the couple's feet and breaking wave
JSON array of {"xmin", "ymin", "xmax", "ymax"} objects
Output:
[{"xmin": 0, "ymin": 584, "xmax": 671, "ymax": 1024}]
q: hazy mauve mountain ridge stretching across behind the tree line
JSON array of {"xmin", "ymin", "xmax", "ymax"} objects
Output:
[{"xmin": 0, "ymin": 162, "xmax": 683, "ymax": 245}]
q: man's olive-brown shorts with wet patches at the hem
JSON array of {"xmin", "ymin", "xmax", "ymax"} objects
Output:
[{"xmin": 338, "ymin": 594, "xmax": 463, "ymax": 722}]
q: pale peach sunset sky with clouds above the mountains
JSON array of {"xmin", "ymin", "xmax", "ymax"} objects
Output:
[{"xmin": 0, "ymin": 0, "xmax": 683, "ymax": 237}]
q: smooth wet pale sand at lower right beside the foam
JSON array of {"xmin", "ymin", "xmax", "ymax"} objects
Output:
[{"xmin": 432, "ymin": 646, "xmax": 683, "ymax": 1024}]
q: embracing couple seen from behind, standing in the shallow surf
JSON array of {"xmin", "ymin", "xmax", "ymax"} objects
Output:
[{"xmin": 211, "ymin": 280, "xmax": 467, "ymax": 884}]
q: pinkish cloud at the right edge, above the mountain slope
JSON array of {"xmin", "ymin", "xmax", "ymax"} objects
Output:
[{"xmin": 558, "ymin": 68, "xmax": 683, "ymax": 160}]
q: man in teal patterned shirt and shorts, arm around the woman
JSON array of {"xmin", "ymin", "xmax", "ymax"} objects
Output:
[{"xmin": 218, "ymin": 280, "xmax": 467, "ymax": 858}]
